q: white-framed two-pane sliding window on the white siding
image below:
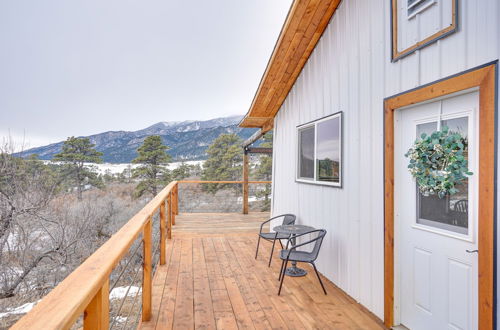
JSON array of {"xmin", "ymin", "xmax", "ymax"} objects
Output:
[{"xmin": 297, "ymin": 112, "xmax": 342, "ymax": 187}]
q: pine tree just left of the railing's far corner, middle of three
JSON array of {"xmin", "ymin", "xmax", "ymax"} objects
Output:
[{"xmin": 132, "ymin": 135, "xmax": 172, "ymax": 197}]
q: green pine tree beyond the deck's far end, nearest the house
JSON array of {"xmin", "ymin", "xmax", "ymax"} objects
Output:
[{"xmin": 202, "ymin": 134, "xmax": 243, "ymax": 194}]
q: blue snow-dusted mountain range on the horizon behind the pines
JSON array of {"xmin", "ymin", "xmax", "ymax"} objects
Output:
[{"xmin": 18, "ymin": 116, "xmax": 256, "ymax": 163}]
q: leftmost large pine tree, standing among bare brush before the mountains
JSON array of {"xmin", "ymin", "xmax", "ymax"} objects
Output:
[{"xmin": 54, "ymin": 136, "xmax": 103, "ymax": 200}]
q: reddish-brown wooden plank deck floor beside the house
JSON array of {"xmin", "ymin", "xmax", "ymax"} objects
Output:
[{"xmin": 139, "ymin": 213, "xmax": 384, "ymax": 329}]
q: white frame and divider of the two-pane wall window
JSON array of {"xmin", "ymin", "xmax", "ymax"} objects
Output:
[{"xmin": 295, "ymin": 111, "xmax": 344, "ymax": 188}]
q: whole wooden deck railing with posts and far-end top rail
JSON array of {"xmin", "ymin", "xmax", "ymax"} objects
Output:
[{"xmin": 12, "ymin": 181, "xmax": 271, "ymax": 329}]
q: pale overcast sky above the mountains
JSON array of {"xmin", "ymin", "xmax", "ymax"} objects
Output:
[{"xmin": 0, "ymin": 0, "xmax": 291, "ymax": 147}]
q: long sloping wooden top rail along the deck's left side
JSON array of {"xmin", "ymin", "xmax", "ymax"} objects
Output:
[{"xmin": 12, "ymin": 181, "xmax": 177, "ymax": 329}]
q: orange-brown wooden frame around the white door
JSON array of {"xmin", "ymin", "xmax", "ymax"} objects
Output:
[{"xmin": 384, "ymin": 60, "xmax": 498, "ymax": 330}]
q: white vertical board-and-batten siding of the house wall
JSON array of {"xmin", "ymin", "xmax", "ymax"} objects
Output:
[{"xmin": 272, "ymin": 0, "xmax": 500, "ymax": 319}]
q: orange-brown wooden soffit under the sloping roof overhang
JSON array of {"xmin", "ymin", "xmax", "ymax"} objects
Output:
[{"xmin": 240, "ymin": 0, "xmax": 340, "ymax": 130}]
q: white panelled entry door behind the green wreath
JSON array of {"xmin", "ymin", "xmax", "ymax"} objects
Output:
[{"xmin": 394, "ymin": 91, "xmax": 479, "ymax": 330}]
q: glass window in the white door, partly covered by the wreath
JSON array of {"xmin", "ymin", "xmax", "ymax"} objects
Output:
[{"xmin": 416, "ymin": 117, "xmax": 469, "ymax": 235}]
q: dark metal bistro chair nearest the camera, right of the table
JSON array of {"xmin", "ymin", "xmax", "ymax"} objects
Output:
[{"xmin": 278, "ymin": 229, "xmax": 326, "ymax": 296}]
